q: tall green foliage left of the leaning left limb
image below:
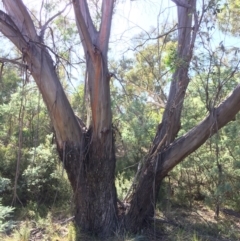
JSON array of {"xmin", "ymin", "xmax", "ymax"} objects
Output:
[{"xmin": 0, "ymin": 77, "xmax": 71, "ymax": 209}]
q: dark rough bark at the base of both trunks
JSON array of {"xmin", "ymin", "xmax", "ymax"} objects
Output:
[{"xmin": 58, "ymin": 133, "xmax": 165, "ymax": 237}]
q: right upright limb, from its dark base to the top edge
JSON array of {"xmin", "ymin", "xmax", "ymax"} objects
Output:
[{"xmin": 126, "ymin": 0, "xmax": 199, "ymax": 232}]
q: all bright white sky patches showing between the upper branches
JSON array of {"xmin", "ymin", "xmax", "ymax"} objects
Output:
[{"xmin": 1, "ymin": 0, "xmax": 239, "ymax": 87}]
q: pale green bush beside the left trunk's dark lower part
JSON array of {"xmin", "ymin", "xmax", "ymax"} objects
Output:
[{"xmin": 0, "ymin": 135, "xmax": 72, "ymax": 211}]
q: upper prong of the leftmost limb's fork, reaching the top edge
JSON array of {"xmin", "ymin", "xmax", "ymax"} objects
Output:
[{"xmin": 3, "ymin": 0, "xmax": 37, "ymax": 40}]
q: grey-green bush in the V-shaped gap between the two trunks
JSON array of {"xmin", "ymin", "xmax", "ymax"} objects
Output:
[{"xmin": 115, "ymin": 95, "xmax": 160, "ymax": 178}]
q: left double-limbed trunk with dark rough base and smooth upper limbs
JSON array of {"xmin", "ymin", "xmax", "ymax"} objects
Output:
[{"xmin": 0, "ymin": 0, "xmax": 117, "ymax": 236}]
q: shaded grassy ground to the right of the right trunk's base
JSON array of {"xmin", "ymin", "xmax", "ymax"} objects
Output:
[{"xmin": 148, "ymin": 205, "xmax": 240, "ymax": 241}]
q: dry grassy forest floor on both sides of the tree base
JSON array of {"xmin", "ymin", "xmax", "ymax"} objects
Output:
[{"xmin": 0, "ymin": 204, "xmax": 240, "ymax": 241}]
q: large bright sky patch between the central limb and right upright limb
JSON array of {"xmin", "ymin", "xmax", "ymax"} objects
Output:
[{"xmin": 110, "ymin": 0, "xmax": 176, "ymax": 55}]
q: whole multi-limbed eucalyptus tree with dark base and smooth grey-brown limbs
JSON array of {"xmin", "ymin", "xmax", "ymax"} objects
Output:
[{"xmin": 0, "ymin": 0, "xmax": 240, "ymax": 236}]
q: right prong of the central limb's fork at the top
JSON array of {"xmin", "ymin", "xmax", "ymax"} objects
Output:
[{"xmin": 99, "ymin": 0, "xmax": 114, "ymax": 54}]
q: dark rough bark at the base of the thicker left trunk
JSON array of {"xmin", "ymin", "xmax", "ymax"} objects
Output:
[{"xmin": 58, "ymin": 130, "xmax": 118, "ymax": 237}]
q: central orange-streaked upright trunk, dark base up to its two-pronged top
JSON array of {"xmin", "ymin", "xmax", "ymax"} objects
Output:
[{"xmin": 66, "ymin": 0, "xmax": 117, "ymax": 236}]
